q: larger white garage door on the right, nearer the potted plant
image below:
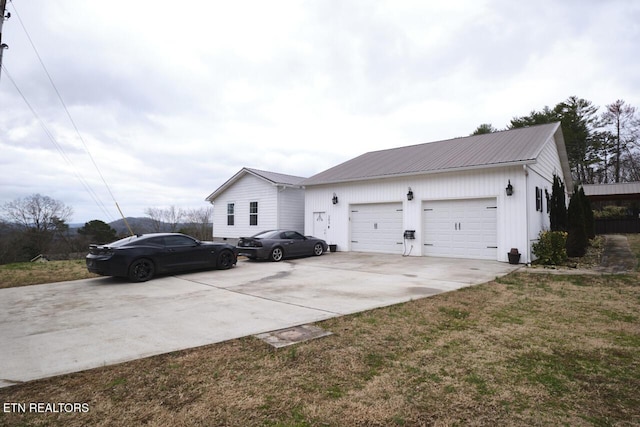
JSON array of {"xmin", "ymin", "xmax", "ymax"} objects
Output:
[{"xmin": 422, "ymin": 199, "xmax": 498, "ymax": 260}]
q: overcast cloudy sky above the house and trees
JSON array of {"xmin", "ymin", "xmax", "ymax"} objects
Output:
[{"xmin": 0, "ymin": 0, "xmax": 640, "ymax": 223}]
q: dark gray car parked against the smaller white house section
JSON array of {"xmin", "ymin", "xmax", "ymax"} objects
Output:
[{"xmin": 238, "ymin": 230, "xmax": 327, "ymax": 262}]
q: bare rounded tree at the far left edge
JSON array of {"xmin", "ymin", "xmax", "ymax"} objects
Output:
[{"xmin": 2, "ymin": 194, "xmax": 73, "ymax": 257}]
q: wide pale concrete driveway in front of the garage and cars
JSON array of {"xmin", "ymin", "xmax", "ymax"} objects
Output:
[{"xmin": 0, "ymin": 252, "xmax": 517, "ymax": 387}]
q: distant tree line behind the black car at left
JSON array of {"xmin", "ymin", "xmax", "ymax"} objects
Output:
[{"xmin": 0, "ymin": 194, "xmax": 213, "ymax": 264}]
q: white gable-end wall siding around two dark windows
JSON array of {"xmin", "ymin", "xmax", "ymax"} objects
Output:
[{"xmin": 213, "ymin": 174, "xmax": 278, "ymax": 239}]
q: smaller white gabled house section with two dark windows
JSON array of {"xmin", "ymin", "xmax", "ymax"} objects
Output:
[{"xmin": 205, "ymin": 168, "xmax": 305, "ymax": 240}]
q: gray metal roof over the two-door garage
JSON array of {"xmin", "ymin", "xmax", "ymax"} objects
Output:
[{"xmin": 303, "ymin": 122, "xmax": 569, "ymax": 186}]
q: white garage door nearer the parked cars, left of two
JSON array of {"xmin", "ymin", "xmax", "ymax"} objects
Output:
[{"xmin": 350, "ymin": 203, "xmax": 403, "ymax": 254}]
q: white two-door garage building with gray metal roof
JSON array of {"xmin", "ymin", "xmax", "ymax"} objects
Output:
[{"xmin": 302, "ymin": 123, "xmax": 573, "ymax": 263}]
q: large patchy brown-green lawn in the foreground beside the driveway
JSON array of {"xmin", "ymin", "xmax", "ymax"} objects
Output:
[{"xmin": 0, "ymin": 236, "xmax": 640, "ymax": 426}]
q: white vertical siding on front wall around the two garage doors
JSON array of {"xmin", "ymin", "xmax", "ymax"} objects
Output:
[{"xmin": 305, "ymin": 166, "xmax": 535, "ymax": 262}]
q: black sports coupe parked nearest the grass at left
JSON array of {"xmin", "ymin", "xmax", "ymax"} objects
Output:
[{"xmin": 86, "ymin": 233, "xmax": 238, "ymax": 282}]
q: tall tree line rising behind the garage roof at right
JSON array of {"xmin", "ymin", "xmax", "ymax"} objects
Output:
[{"xmin": 472, "ymin": 96, "xmax": 640, "ymax": 184}]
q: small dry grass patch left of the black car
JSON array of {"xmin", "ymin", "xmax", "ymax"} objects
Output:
[{"xmin": 0, "ymin": 259, "xmax": 98, "ymax": 289}]
